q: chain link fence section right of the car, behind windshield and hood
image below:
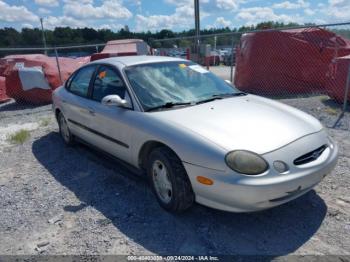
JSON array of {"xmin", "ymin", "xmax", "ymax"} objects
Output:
[{"xmin": 152, "ymin": 23, "xmax": 350, "ymax": 107}]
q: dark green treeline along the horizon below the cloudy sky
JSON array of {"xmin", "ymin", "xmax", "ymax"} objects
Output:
[{"xmin": 0, "ymin": 21, "xmax": 350, "ymax": 52}]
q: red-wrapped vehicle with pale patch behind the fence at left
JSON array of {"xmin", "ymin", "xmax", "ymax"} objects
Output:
[{"xmin": 0, "ymin": 54, "xmax": 89, "ymax": 104}]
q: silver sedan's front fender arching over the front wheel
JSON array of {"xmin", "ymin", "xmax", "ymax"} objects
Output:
[{"xmin": 127, "ymin": 112, "xmax": 227, "ymax": 171}]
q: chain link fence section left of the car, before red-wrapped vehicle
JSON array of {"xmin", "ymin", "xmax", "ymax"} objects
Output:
[{"xmin": 0, "ymin": 44, "xmax": 105, "ymax": 104}]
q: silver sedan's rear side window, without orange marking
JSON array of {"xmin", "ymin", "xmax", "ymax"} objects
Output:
[{"xmin": 68, "ymin": 66, "xmax": 96, "ymax": 97}]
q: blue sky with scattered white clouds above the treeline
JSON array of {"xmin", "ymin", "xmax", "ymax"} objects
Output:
[{"xmin": 0, "ymin": 0, "xmax": 350, "ymax": 32}]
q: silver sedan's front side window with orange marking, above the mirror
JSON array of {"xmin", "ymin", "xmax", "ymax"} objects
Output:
[{"xmin": 92, "ymin": 66, "xmax": 127, "ymax": 102}]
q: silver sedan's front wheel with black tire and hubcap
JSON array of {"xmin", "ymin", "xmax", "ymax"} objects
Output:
[{"xmin": 147, "ymin": 147, "xmax": 194, "ymax": 213}]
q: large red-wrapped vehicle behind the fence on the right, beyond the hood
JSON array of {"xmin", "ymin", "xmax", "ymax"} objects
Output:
[{"xmin": 234, "ymin": 28, "xmax": 350, "ymax": 95}]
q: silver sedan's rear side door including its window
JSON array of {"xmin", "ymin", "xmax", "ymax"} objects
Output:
[{"xmin": 62, "ymin": 65, "xmax": 97, "ymax": 142}]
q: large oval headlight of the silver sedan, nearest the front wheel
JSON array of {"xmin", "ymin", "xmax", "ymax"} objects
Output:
[{"xmin": 225, "ymin": 150, "xmax": 269, "ymax": 175}]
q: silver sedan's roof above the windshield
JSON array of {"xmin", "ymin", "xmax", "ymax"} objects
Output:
[{"xmin": 91, "ymin": 55, "xmax": 187, "ymax": 67}]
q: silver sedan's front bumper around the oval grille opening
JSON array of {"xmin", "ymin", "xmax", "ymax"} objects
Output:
[{"xmin": 184, "ymin": 131, "xmax": 338, "ymax": 212}]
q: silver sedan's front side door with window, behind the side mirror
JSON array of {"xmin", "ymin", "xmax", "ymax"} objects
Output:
[{"xmin": 85, "ymin": 65, "xmax": 136, "ymax": 162}]
